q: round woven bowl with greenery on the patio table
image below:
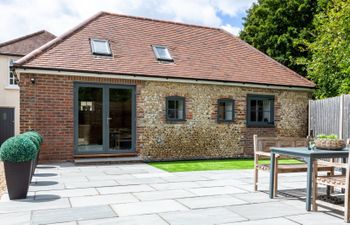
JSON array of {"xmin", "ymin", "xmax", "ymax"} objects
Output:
[{"xmin": 315, "ymin": 134, "xmax": 345, "ymax": 150}]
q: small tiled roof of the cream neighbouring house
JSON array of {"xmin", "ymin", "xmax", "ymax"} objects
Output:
[{"xmin": 0, "ymin": 30, "xmax": 56, "ymax": 56}]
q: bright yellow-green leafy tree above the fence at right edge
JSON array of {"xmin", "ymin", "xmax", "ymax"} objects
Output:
[{"xmin": 308, "ymin": 0, "xmax": 350, "ymax": 98}]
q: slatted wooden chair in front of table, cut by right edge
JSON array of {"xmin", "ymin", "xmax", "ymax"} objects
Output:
[{"xmin": 312, "ymin": 139, "xmax": 350, "ymax": 223}]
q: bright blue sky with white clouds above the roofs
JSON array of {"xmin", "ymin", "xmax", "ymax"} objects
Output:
[{"xmin": 0, "ymin": 0, "xmax": 256, "ymax": 42}]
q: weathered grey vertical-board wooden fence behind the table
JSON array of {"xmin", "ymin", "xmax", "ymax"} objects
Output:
[{"xmin": 309, "ymin": 95, "xmax": 350, "ymax": 139}]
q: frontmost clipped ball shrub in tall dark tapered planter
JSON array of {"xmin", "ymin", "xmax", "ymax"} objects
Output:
[{"xmin": 0, "ymin": 135, "xmax": 37, "ymax": 200}]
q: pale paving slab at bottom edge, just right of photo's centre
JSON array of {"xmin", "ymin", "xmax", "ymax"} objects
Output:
[{"xmin": 160, "ymin": 208, "xmax": 247, "ymax": 225}]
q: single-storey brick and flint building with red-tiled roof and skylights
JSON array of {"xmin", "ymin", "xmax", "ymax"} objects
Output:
[{"xmin": 15, "ymin": 12, "xmax": 315, "ymax": 161}]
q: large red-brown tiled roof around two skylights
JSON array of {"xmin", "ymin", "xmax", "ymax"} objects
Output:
[{"xmin": 16, "ymin": 12, "xmax": 315, "ymax": 88}]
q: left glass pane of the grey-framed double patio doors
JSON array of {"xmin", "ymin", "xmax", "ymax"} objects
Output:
[{"xmin": 78, "ymin": 87, "xmax": 103, "ymax": 153}]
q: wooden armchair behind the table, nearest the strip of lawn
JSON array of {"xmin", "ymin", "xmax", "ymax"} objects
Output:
[{"xmin": 253, "ymin": 135, "xmax": 333, "ymax": 194}]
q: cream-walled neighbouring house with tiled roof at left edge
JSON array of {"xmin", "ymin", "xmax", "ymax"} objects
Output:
[{"xmin": 0, "ymin": 30, "xmax": 55, "ymax": 145}]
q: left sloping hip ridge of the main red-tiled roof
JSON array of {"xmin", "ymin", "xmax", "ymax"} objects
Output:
[{"xmin": 15, "ymin": 12, "xmax": 104, "ymax": 66}]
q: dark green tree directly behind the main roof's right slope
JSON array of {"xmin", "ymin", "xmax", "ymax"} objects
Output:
[{"xmin": 240, "ymin": 0, "xmax": 326, "ymax": 76}]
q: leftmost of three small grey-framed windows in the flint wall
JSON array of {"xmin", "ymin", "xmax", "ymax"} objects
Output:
[{"xmin": 166, "ymin": 96, "xmax": 186, "ymax": 121}]
